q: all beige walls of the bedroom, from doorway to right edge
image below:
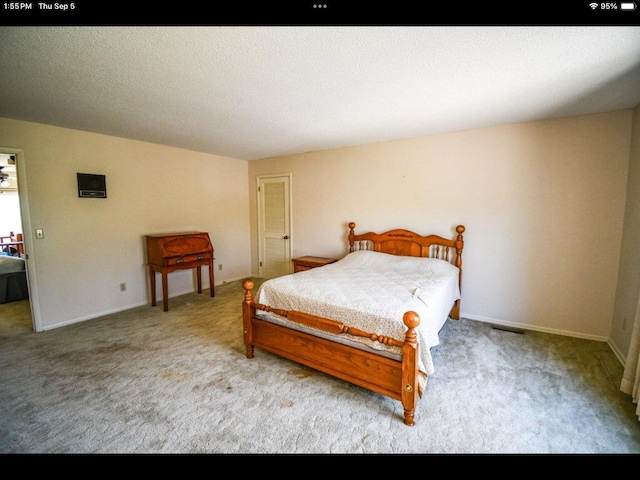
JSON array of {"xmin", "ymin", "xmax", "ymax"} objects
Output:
[{"xmin": 0, "ymin": 107, "xmax": 640, "ymax": 356}]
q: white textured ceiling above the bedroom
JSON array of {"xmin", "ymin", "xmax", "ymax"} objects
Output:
[{"xmin": 0, "ymin": 26, "xmax": 640, "ymax": 160}]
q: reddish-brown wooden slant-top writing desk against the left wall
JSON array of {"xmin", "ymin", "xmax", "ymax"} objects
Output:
[{"xmin": 145, "ymin": 232, "xmax": 215, "ymax": 312}]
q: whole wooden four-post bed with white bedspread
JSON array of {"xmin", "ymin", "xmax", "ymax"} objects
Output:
[{"xmin": 242, "ymin": 222, "xmax": 465, "ymax": 425}]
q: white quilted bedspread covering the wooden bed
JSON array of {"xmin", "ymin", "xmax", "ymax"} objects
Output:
[{"xmin": 256, "ymin": 250, "xmax": 460, "ymax": 375}]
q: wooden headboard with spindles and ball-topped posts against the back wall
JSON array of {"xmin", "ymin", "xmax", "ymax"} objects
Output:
[{"xmin": 349, "ymin": 222, "xmax": 465, "ymax": 319}]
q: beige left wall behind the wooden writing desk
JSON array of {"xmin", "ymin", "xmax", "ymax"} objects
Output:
[{"xmin": 0, "ymin": 119, "xmax": 250, "ymax": 330}]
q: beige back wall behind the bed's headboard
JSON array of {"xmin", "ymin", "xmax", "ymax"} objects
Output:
[{"xmin": 249, "ymin": 110, "xmax": 632, "ymax": 346}]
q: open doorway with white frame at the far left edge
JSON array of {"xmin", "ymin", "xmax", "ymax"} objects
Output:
[{"xmin": 0, "ymin": 147, "xmax": 43, "ymax": 332}]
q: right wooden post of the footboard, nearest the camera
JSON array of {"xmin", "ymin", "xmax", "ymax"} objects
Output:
[{"xmin": 401, "ymin": 311, "xmax": 420, "ymax": 426}]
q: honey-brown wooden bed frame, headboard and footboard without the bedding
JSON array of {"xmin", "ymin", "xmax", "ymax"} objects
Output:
[{"xmin": 242, "ymin": 222, "xmax": 465, "ymax": 425}]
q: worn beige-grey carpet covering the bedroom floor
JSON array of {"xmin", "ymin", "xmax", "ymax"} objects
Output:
[{"xmin": 0, "ymin": 282, "xmax": 640, "ymax": 454}]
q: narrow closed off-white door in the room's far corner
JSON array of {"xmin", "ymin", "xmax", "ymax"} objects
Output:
[{"xmin": 258, "ymin": 175, "xmax": 292, "ymax": 279}]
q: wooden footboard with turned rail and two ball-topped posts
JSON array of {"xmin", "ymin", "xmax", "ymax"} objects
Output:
[{"xmin": 242, "ymin": 279, "xmax": 422, "ymax": 425}]
